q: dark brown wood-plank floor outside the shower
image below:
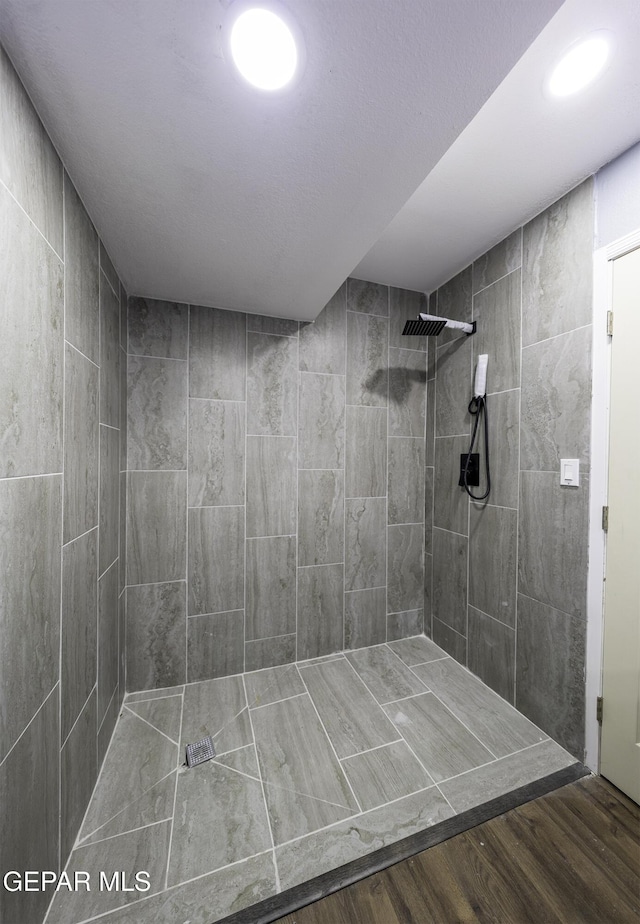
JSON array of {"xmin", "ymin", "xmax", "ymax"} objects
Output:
[{"xmin": 279, "ymin": 777, "xmax": 640, "ymax": 924}]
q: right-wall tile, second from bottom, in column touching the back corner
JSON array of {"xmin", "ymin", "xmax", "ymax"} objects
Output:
[{"xmin": 433, "ymin": 529, "xmax": 468, "ymax": 651}]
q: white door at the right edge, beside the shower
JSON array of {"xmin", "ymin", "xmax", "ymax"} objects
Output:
[{"xmin": 600, "ymin": 250, "xmax": 640, "ymax": 803}]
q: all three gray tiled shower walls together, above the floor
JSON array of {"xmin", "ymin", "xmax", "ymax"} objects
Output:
[{"xmin": 0, "ymin": 41, "xmax": 593, "ymax": 922}]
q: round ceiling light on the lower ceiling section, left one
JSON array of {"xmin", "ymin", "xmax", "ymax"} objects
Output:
[{"xmin": 229, "ymin": 4, "xmax": 300, "ymax": 91}]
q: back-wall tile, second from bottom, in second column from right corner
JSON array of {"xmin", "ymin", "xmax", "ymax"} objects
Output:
[{"xmin": 345, "ymin": 497, "xmax": 387, "ymax": 590}]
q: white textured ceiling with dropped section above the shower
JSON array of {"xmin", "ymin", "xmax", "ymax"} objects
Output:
[{"xmin": 0, "ymin": 0, "xmax": 640, "ymax": 320}]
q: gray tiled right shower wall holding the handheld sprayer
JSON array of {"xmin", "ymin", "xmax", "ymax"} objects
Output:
[{"xmin": 424, "ymin": 180, "xmax": 594, "ymax": 759}]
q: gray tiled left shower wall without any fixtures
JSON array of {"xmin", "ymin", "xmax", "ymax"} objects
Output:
[{"xmin": 0, "ymin": 48, "xmax": 126, "ymax": 922}]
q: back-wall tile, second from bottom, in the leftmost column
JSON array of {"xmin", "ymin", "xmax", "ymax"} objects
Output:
[{"xmin": 127, "ymin": 472, "xmax": 187, "ymax": 584}]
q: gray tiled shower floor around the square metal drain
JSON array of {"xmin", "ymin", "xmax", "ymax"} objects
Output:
[{"xmin": 46, "ymin": 636, "xmax": 576, "ymax": 924}]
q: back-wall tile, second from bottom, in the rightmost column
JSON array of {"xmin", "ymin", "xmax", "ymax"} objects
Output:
[{"xmin": 387, "ymin": 523, "xmax": 424, "ymax": 613}]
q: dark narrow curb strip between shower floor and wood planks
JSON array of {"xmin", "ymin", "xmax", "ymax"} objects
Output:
[{"xmin": 219, "ymin": 761, "xmax": 593, "ymax": 924}]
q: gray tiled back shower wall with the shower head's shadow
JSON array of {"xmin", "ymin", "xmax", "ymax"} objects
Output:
[{"xmin": 126, "ymin": 279, "xmax": 427, "ymax": 690}]
